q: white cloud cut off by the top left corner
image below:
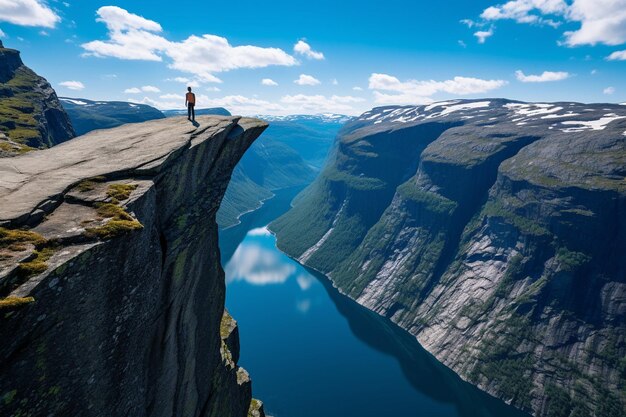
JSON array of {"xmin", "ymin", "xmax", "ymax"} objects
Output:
[{"xmin": 0, "ymin": 0, "xmax": 61, "ymax": 28}]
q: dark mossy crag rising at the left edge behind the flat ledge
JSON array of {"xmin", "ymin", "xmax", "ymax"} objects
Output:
[{"xmin": 0, "ymin": 42, "xmax": 76, "ymax": 156}]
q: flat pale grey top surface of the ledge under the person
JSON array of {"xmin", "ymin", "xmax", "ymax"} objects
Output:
[{"xmin": 0, "ymin": 116, "xmax": 265, "ymax": 225}]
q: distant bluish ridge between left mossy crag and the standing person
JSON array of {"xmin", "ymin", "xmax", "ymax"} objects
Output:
[{"xmin": 59, "ymin": 97, "xmax": 165, "ymax": 135}]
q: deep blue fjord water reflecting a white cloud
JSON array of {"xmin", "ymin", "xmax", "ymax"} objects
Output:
[{"xmin": 220, "ymin": 188, "xmax": 525, "ymax": 417}]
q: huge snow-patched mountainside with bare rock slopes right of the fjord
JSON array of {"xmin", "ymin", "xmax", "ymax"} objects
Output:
[{"xmin": 271, "ymin": 100, "xmax": 626, "ymax": 416}]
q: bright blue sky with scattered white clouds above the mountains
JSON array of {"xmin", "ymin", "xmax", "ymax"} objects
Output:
[{"xmin": 0, "ymin": 0, "xmax": 626, "ymax": 114}]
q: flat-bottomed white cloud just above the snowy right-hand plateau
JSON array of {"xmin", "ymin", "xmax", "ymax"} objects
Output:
[{"xmin": 369, "ymin": 73, "xmax": 507, "ymax": 104}]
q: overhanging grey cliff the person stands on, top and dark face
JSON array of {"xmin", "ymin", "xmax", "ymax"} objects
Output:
[{"xmin": 0, "ymin": 116, "xmax": 267, "ymax": 417}]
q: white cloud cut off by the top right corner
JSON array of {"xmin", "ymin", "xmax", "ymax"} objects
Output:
[{"xmin": 472, "ymin": 0, "xmax": 626, "ymax": 47}]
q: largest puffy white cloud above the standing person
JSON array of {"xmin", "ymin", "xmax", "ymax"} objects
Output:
[{"xmin": 81, "ymin": 6, "xmax": 297, "ymax": 82}]
